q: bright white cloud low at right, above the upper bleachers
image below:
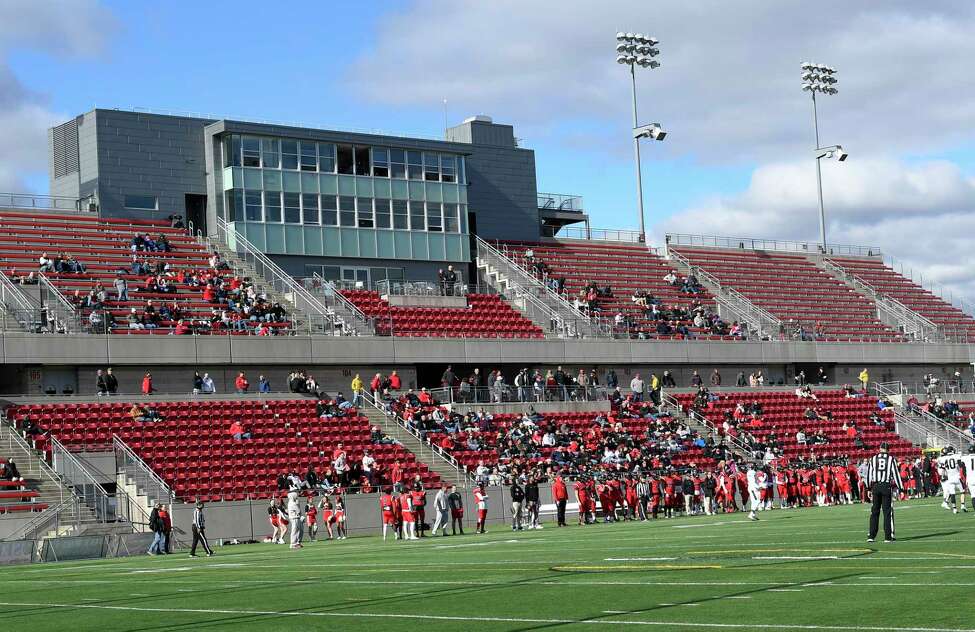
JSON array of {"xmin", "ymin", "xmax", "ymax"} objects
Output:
[{"xmin": 655, "ymin": 157, "xmax": 975, "ymax": 302}]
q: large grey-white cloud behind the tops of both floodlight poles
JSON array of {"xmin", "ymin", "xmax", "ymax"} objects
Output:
[{"xmin": 347, "ymin": 0, "xmax": 975, "ymax": 162}]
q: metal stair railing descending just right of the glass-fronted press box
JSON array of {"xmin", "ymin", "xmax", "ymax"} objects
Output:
[{"xmin": 475, "ymin": 237, "xmax": 607, "ymax": 338}]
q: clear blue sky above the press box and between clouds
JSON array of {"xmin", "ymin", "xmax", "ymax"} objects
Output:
[{"xmin": 8, "ymin": 1, "xmax": 754, "ymax": 228}]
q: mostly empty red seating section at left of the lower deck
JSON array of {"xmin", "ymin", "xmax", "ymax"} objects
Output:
[{"xmin": 7, "ymin": 399, "xmax": 440, "ymax": 501}]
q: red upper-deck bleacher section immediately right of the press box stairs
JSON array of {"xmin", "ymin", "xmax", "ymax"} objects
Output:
[{"xmin": 496, "ymin": 241, "xmax": 736, "ymax": 340}]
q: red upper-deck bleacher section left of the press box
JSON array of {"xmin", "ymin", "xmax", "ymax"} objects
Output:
[{"xmin": 0, "ymin": 211, "xmax": 288, "ymax": 334}]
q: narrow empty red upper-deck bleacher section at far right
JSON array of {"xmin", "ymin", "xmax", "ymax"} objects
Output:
[{"xmin": 829, "ymin": 257, "xmax": 975, "ymax": 342}]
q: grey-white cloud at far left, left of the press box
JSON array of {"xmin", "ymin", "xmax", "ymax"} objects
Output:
[{"xmin": 0, "ymin": 0, "xmax": 115, "ymax": 192}]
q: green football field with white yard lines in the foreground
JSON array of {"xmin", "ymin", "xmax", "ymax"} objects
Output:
[{"xmin": 0, "ymin": 499, "xmax": 975, "ymax": 632}]
